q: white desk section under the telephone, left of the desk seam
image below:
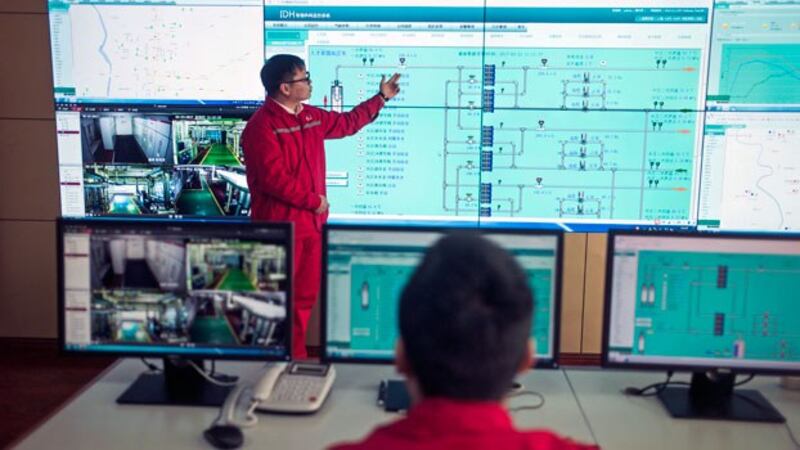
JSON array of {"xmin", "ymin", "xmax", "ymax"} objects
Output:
[{"xmin": 18, "ymin": 359, "xmax": 592, "ymax": 450}]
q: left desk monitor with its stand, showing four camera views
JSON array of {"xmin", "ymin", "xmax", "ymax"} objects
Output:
[{"xmin": 58, "ymin": 218, "xmax": 293, "ymax": 406}]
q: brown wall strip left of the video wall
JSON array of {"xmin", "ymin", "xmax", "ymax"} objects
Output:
[{"xmin": 0, "ymin": 0, "xmax": 58, "ymax": 337}]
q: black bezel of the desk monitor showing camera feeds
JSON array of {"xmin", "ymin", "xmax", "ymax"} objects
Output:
[{"xmin": 56, "ymin": 217, "xmax": 294, "ymax": 361}]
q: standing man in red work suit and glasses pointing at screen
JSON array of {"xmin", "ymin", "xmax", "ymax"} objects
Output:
[{"xmin": 242, "ymin": 55, "xmax": 400, "ymax": 359}]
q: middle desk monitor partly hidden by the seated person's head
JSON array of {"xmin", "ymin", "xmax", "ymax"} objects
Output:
[{"xmin": 321, "ymin": 225, "xmax": 562, "ymax": 367}]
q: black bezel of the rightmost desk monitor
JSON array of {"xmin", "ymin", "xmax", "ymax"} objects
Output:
[{"xmin": 601, "ymin": 230, "xmax": 800, "ymax": 375}]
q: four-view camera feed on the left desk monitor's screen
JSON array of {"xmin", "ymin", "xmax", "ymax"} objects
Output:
[{"xmin": 64, "ymin": 227, "xmax": 290, "ymax": 355}]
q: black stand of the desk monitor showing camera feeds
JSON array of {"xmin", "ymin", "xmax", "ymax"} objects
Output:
[{"xmin": 117, "ymin": 358, "xmax": 235, "ymax": 407}]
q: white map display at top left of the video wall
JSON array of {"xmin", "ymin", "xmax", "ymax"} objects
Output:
[{"xmin": 48, "ymin": 0, "xmax": 264, "ymax": 105}]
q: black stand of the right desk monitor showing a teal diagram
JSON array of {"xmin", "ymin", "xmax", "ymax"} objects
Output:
[{"xmin": 658, "ymin": 372, "xmax": 786, "ymax": 423}]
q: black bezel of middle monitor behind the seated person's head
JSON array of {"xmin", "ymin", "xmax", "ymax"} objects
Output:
[{"xmin": 320, "ymin": 224, "xmax": 564, "ymax": 369}]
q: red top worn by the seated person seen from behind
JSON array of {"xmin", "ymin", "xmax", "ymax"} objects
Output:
[{"xmin": 330, "ymin": 398, "xmax": 599, "ymax": 450}]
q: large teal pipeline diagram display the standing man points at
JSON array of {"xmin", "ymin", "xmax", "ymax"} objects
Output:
[{"xmin": 265, "ymin": 1, "xmax": 711, "ymax": 226}]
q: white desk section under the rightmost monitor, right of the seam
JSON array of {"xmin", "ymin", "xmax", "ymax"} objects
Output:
[{"xmin": 567, "ymin": 369, "xmax": 800, "ymax": 450}]
